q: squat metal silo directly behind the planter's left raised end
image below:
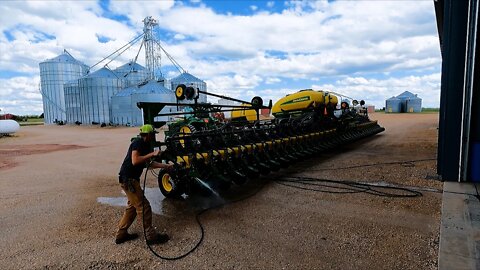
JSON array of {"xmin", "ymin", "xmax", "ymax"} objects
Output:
[{"xmin": 132, "ymin": 80, "xmax": 175, "ymax": 126}]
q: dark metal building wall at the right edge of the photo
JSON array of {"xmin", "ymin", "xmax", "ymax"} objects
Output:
[{"xmin": 434, "ymin": 0, "xmax": 480, "ymax": 182}]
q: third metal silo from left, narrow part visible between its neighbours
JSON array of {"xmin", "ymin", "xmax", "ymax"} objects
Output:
[{"xmin": 111, "ymin": 85, "xmax": 138, "ymax": 126}]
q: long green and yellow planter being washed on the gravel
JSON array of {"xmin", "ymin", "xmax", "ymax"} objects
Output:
[{"xmin": 137, "ymin": 84, "xmax": 385, "ymax": 197}]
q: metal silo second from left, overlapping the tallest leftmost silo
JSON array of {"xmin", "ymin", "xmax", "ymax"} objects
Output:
[{"xmin": 78, "ymin": 67, "xmax": 127, "ymax": 125}]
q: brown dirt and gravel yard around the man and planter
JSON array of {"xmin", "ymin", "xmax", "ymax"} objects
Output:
[{"xmin": 0, "ymin": 114, "xmax": 442, "ymax": 269}]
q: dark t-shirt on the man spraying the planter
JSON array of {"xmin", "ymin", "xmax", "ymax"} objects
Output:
[{"xmin": 118, "ymin": 138, "xmax": 151, "ymax": 183}]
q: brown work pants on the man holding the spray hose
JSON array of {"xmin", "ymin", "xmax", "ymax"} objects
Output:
[{"xmin": 116, "ymin": 179, "xmax": 156, "ymax": 240}]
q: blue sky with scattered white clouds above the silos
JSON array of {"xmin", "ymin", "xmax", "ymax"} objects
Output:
[{"xmin": 0, "ymin": 0, "xmax": 441, "ymax": 114}]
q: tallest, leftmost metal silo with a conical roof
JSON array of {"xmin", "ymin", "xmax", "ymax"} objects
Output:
[{"xmin": 39, "ymin": 50, "xmax": 88, "ymax": 124}]
